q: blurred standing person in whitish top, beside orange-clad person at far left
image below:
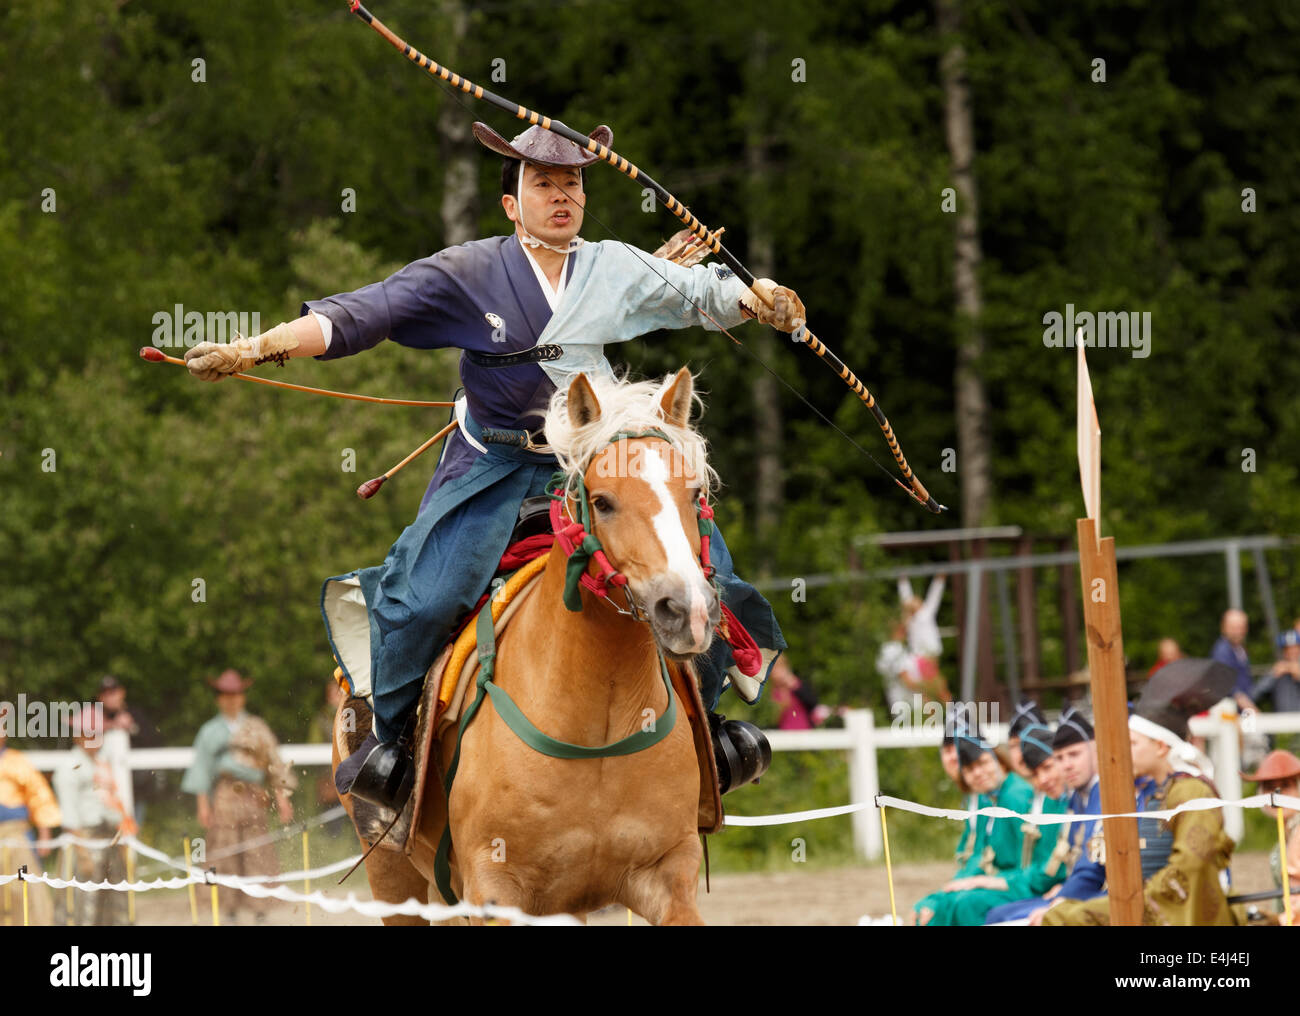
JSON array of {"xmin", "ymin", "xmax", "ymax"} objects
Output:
[{"xmin": 55, "ymin": 705, "xmax": 135, "ymax": 925}]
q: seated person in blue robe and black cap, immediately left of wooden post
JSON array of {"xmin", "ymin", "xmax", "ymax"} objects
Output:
[{"xmin": 984, "ymin": 705, "xmax": 1106, "ymax": 924}]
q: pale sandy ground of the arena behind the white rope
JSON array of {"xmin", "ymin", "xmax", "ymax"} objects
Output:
[{"xmin": 10, "ymin": 852, "xmax": 1271, "ymax": 926}]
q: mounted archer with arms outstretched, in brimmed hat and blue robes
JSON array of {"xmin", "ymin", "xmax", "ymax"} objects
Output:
[{"xmin": 185, "ymin": 123, "xmax": 805, "ymax": 811}]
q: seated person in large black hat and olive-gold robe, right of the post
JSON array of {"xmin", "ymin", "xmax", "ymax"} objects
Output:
[{"xmin": 1043, "ymin": 660, "xmax": 1236, "ymax": 926}]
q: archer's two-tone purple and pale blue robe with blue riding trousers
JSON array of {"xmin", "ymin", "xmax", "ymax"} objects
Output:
[{"xmin": 309, "ymin": 236, "xmax": 785, "ymax": 741}]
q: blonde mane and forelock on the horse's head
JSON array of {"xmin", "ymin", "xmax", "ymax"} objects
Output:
[{"xmin": 545, "ymin": 374, "xmax": 718, "ymax": 494}]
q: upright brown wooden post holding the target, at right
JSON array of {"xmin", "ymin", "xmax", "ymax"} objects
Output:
[{"xmin": 1078, "ymin": 518, "xmax": 1143, "ymax": 926}]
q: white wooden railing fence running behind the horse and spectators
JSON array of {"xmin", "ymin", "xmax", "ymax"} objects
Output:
[{"xmin": 25, "ymin": 709, "xmax": 1300, "ymax": 860}]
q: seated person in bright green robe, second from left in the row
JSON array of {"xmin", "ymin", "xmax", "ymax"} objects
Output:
[{"xmin": 913, "ymin": 728, "xmax": 1034, "ymax": 925}]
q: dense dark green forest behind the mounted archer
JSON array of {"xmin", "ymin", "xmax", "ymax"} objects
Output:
[{"xmin": 0, "ymin": 0, "xmax": 1300, "ymax": 743}]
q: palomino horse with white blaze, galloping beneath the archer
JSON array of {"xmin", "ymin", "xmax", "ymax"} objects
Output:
[{"xmin": 335, "ymin": 368, "xmax": 720, "ymax": 924}]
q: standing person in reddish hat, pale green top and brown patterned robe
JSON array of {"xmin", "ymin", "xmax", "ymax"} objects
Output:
[{"xmin": 181, "ymin": 670, "xmax": 296, "ymax": 922}]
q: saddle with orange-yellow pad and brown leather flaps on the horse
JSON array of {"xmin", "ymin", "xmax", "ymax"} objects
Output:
[{"xmin": 341, "ymin": 517, "xmax": 724, "ymax": 855}]
